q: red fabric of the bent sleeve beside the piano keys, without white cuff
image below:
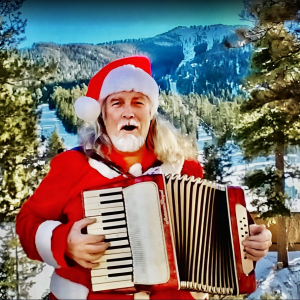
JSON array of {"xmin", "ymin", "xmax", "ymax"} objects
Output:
[{"xmin": 16, "ymin": 151, "xmax": 88, "ymax": 266}]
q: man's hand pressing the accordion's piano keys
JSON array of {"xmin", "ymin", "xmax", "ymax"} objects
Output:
[{"xmin": 66, "ymin": 218, "xmax": 110, "ymax": 268}]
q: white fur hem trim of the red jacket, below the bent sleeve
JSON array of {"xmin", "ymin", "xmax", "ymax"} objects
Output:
[{"xmin": 50, "ymin": 272, "xmax": 89, "ymax": 299}]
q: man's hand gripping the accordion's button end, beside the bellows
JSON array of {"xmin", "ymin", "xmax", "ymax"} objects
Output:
[{"xmin": 242, "ymin": 224, "xmax": 272, "ymax": 261}]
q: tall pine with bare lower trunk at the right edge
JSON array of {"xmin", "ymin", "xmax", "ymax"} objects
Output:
[{"xmin": 237, "ymin": 0, "xmax": 300, "ymax": 267}]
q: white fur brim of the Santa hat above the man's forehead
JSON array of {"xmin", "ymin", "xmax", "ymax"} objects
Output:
[{"xmin": 99, "ymin": 65, "xmax": 159, "ymax": 112}]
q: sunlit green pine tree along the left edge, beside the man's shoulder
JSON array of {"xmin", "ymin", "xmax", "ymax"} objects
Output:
[{"xmin": 0, "ymin": 0, "xmax": 51, "ymax": 223}]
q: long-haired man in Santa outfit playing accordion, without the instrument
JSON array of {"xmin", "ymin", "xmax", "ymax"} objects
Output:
[{"xmin": 17, "ymin": 56, "xmax": 271, "ymax": 299}]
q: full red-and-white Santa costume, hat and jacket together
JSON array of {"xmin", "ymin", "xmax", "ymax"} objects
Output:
[{"xmin": 16, "ymin": 56, "xmax": 203, "ymax": 299}]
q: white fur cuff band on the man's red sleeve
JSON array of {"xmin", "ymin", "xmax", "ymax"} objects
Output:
[{"xmin": 35, "ymin": 221, "xmax": 61, "ymax": 268}]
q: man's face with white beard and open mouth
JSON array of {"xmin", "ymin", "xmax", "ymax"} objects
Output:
[{"xmin": 103, "ymin": 92, "xmax": 151, "ymax": 152}]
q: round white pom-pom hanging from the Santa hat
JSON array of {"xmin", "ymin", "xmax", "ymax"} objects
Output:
[{"xmin": 74, "ymin": 96, "xmax": 101, "ymax": 122}]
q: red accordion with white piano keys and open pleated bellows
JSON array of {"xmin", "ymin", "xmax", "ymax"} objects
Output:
[{"xmin": 82, "ymin": 175, "xmax": 256, "ymax": 296}]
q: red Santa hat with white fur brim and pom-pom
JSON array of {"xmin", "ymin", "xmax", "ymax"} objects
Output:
[{"xmin": 74, "ymin": 56, "xmax": 159, "ymax": 122}]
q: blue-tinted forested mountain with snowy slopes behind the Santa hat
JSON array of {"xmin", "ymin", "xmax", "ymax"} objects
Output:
[{"xmin": 22, "ymin": 24, "xmax": 251, "ymax": 95}]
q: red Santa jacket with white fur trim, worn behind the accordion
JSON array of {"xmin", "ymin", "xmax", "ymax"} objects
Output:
[{"xmin": 16, "ymin": 150, "xmax": 203, "ymax": 299}]
